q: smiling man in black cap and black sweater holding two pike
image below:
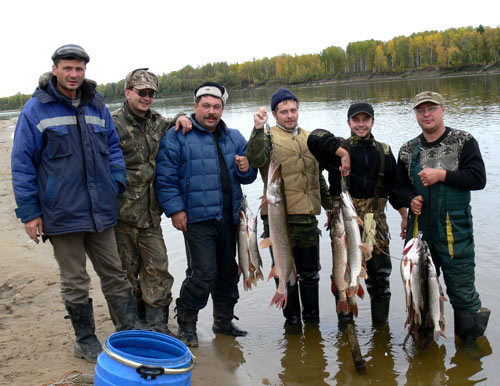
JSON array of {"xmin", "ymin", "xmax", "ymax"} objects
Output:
[{"xmin": 307, "ymin": 102, "xmax": 407, "ymax": 325}]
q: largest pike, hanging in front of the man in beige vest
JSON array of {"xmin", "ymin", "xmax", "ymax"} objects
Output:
[{"xmin": 260, "ymin": 160, "xmax": 297, "ymax": 308}]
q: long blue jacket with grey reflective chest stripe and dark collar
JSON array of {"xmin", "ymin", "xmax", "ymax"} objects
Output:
[{"xmin": 11, "ymin": 74, "xmax": 126, "ymax": 235}]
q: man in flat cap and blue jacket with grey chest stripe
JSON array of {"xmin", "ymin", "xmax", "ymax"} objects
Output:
[{"xmin": 12, "ymin": 44, "xmax": 137, "ymax": 362}]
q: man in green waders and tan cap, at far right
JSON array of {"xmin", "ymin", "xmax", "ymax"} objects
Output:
[{"xmin": 396, "ymin": 91, "xmax": 490, "ymax": 341}]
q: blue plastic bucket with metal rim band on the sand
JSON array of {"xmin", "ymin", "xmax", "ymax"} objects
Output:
[{"xmin": 94, "ymin": 330, "xmax": 195, "ymax": 386}]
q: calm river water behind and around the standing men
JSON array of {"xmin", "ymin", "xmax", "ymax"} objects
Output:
[{"xmin": 155, "ymin": 75, "xmax": 500, "ymax": 385}]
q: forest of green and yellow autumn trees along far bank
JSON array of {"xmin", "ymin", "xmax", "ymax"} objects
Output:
[{"xmin": 0, "ymin": 25, "xmax": 500, "ymax": 110}]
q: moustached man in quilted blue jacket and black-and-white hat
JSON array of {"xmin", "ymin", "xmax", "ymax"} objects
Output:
[{"xmin": 156, "ymin": 82, "xmax": 257, "ymax": 347}]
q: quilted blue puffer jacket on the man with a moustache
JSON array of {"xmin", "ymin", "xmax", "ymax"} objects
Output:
[{"xmin": 156, "ymin": 116, "xmax": 257, "ymax": 224}]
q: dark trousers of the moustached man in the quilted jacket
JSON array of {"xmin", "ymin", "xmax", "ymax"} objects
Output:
[{"xmin": 177, "ymin": 211, "xmax": 239, "ymax": 310}]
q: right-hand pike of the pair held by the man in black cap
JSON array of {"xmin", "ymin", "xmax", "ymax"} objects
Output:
[{"xmin": 340, "ymin": 191, "xmax": 372, "ymax": 298}]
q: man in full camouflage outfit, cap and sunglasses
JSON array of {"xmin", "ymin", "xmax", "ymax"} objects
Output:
[{"xmin": 111, "ymin": 68, "xmax": 191, "ymax": 334}]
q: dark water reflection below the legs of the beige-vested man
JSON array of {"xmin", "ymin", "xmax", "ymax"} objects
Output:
[{"xmin": 278, "ymin": 323, "xmax": 329, "ymax": 386}]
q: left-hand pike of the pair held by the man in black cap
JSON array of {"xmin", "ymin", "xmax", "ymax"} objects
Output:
[{"xmin": 330, "ymin": 208, "xmax": 350, "ymax": 315}]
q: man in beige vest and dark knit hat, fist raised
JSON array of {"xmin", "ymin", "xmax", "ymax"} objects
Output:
[{"xmin": 246, "ymin": 88, "xmax": 348, "ymax": 326}]
